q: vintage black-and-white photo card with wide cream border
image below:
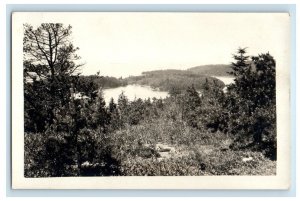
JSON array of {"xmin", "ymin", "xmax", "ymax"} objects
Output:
[{"xmin": 11, "ymin": 12, "xmax": 291, "ymax": 189}]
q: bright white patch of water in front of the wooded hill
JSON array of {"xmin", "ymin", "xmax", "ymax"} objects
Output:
[{"xmin": 103, "ymin": 85, "xmax": 168, "ymax": 103}]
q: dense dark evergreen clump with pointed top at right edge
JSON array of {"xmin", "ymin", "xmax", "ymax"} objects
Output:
[{"xmin": 226, "ymin": 49, "xmax": 276, "ymax": 157}]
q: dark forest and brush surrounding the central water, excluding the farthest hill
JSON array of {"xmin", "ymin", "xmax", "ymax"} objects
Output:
[{"xmin": 23, "ymin": 23, "xmax": 277, "ymax": 177}]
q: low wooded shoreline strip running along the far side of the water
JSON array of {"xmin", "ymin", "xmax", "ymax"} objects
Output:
[{"xmin": 77, "ymin": 67, "xmax": 224, "ymax": 91}]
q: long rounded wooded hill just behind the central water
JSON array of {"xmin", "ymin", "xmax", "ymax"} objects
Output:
[{"xmin": 126, "ymin": 69, "xmax": 225, "ymax": 91}]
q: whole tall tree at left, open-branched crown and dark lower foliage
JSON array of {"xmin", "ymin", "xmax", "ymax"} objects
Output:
[{"xmin": 23, "ymin": 23, "xmax": 81, "ymax": 131}]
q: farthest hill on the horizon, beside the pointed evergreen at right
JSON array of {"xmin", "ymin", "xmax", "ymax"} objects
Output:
[{"xmin": 187, "ymin": 64, "xmax": 232, "ymax": 76}]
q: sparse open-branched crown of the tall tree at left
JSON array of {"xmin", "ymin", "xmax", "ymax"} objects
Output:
[{"xmin": 23, "ymin": 23, "xmax": 81, "ymax": 77}]
